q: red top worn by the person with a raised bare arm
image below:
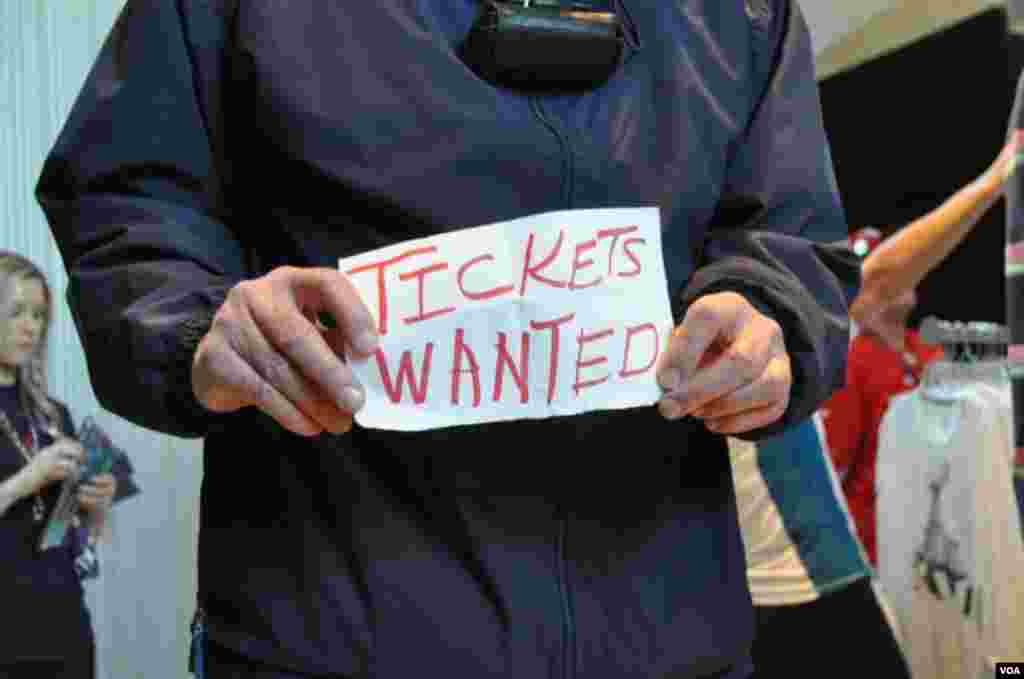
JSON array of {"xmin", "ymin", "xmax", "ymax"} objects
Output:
[{"xmin": 821, "ymin": 330, "xmax": 942, "ymax": 564}]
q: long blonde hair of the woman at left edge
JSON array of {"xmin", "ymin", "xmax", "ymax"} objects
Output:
[{"xmin": 0, "ymin": 250, "xmax": 62, "ymax": 430}]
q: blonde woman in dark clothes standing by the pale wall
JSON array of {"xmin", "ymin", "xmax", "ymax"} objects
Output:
[{"xmin": 0, "ymin": 252, "xmax": 116, "ymax": 679}]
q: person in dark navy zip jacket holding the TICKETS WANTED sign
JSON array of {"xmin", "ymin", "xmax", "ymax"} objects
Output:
[{"xmin": 38, "ymin": 0, "xmax": 858, "ymax": 679}]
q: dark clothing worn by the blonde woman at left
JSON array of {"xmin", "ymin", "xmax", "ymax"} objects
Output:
[{"xmin": 0, "ymin": 385, "xmax": 92, "ymax": 665}]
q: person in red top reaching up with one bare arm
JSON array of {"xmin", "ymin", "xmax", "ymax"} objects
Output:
[{"xmin": 821, "ymin": 144, "xmax": 1013, "ymax": 564}]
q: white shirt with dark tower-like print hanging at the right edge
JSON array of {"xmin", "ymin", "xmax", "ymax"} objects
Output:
[{"xmin": 876, "ymin": 383, "xmax": 1024, "ymax": 679}]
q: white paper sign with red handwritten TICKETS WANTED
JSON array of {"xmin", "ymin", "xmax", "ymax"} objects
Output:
[{"xmin": 339, "ymin": 208, "xmax": 672, "ymax": 431}]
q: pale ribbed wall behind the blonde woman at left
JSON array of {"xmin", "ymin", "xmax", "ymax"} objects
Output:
[{"xmin": 0, "ymin": 0, "xmax": 202, "ymax": 679}]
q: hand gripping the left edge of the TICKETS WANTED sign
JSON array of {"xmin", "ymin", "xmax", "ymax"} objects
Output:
[{"xmin": 191, "ymin": 266, "xmax": 378, "ymax": 436}]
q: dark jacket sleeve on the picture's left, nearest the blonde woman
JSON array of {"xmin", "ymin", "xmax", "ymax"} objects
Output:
[{"xmin": 37, "ymin": 0, "xmax": 246, "ymax": 436}]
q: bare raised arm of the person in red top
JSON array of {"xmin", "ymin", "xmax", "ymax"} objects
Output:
[{"xmin": 851, "ymin": 144, "xmax": 1013, "ymax": 313}]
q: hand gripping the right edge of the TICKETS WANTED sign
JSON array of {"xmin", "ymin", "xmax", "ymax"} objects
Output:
[{"xmin": 657, "ymin": 292, "xmax": 793, "ymax": 434}]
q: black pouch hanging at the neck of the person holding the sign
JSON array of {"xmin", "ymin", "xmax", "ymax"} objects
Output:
[{"xmin": 459, "ymin": 0, "xmax": 625, "ymax": 92}]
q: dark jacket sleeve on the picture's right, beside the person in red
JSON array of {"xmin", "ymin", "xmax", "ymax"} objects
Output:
[{"xmin": 676, "ymin": 0, "xmax": 860, "ymax": 440}]
